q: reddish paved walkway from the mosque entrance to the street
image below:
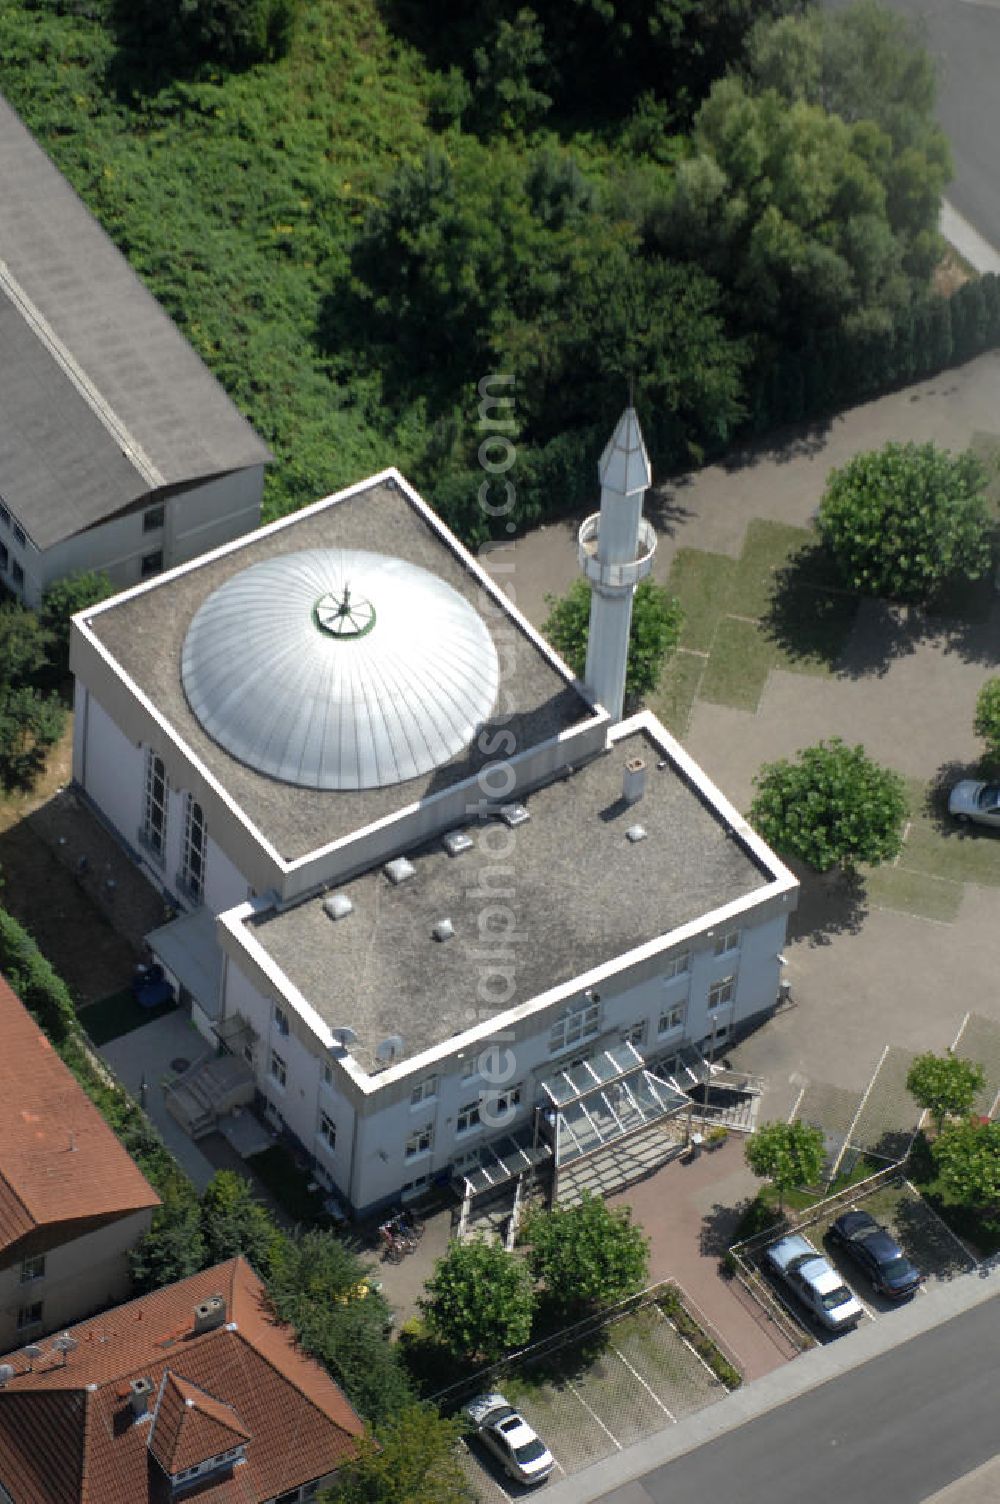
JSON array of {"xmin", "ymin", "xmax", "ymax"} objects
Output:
[{"xmin": 609, "ymin": 1137, "xmax": 794, "ymax": 1379}]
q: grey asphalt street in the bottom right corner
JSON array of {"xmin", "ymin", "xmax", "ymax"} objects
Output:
[{"xmin": 603, "ymin": 1298, "xmax": 1000, "ymax": 1504}]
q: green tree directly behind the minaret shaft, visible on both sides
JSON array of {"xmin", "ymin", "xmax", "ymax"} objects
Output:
[{"xmin": 541, "ymin": 579, "xmax": 684, "ymax": 704}]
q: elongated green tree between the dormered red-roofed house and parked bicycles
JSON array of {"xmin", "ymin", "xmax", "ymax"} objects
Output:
[{"xmin": 268, "ymin": 1230, "xmax": 414, "ymax": 1426}]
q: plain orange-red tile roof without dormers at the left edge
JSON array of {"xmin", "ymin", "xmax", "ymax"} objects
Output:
[{"xmin": 0, "ymin": 976, "xmax": 159, "ymax": 1262}]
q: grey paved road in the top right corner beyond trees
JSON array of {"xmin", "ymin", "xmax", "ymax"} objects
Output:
[{"xmin": 848, "ymin": 0, "xmax": 1000, "ymax": 248}]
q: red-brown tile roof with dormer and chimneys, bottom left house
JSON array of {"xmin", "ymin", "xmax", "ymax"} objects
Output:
[{"xmin": 0, "ymin": 1259, "xmax": 364, "ymax": 1504}]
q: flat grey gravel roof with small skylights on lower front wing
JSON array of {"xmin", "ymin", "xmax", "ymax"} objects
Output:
[{"xmin": 247, "ymin": 729, "xmax": 774, "ymax": 1069}]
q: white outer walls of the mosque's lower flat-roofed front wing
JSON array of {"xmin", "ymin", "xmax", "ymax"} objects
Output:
[{"xmin": 216, "ymin": 905, "xmax": 786, "ymax": 1211}]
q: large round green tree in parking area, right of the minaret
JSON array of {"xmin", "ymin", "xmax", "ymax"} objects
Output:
[{"xmin": 818, "ymin": 444, "xmax": 991, "ymax": 603}]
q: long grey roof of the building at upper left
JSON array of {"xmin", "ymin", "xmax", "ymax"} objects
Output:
[{"xmin": 0, "ymin": 89, "xmax": 271, "ymax": 549}]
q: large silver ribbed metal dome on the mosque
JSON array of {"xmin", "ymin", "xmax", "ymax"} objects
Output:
[{"xmin": 180, "ymin": 549, "xmax": 499, "ymax": 788}]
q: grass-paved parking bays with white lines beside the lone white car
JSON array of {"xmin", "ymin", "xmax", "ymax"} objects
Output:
[{"xmin": 463, "ymin": 1302, "xmax": 726, "ymax": 1504}]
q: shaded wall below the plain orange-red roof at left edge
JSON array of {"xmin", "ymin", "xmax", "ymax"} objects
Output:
[{"xmin": 0, "ymin": 1209, "xmax": 153, "ymax": 1352}]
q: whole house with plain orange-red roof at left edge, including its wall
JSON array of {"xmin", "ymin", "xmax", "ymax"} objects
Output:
[{"xmin": 0, "ymin": 978, "xmax": 159, "ymax": 1352}]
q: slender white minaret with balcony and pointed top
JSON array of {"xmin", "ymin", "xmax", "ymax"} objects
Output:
[{"xmin": 579, "ymin": 406, "xmax": 656, "ymax": 722}]
